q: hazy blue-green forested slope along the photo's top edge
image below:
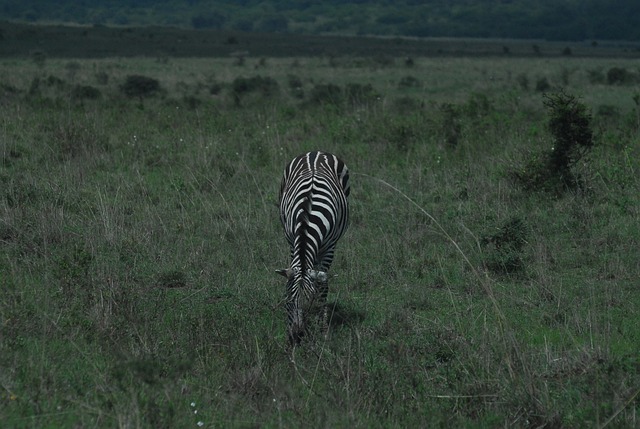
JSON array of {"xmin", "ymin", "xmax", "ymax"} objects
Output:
[{"xmin": 5, "ymin": 0, "xmax": 640, "ymax": 41}]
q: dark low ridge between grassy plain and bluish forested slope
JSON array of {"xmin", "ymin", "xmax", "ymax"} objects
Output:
[{"xmin": 5, "ymin": 21, "xmax": 640, "ymax": 59}]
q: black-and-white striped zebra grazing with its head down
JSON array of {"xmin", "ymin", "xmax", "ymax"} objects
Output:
[{"xmin": 277, "ymin": 152, "xmax": 349, "ymax": 345}]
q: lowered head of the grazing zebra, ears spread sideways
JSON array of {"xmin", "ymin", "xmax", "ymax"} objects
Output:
[{"xmin": 276, "ymin": 268, "xmax": 328, "ymax": 345}]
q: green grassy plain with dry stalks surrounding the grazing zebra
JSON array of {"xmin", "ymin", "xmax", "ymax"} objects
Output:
[{"xmin": 0, "ymin": 41, "xmax": 640, "ymax": 428}]
